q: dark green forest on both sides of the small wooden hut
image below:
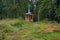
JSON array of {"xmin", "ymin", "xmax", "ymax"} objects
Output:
[{"xmin": 0, "ymin": 0, "xmax": 60, "ymax": 21}]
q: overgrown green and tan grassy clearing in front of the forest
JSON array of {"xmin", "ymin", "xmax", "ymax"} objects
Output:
[{"xmin": 0, "ymin": 19, "xmax": 60, "ymax": 40}]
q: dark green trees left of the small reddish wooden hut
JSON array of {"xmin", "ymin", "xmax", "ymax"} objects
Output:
[{"xmin": 0, "ymin": 0, "xmax": 28, "ymax": 19}]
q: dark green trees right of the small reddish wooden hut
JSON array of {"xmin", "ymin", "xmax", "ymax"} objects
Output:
[{"xmin": 37, "ymin": 0, "xmax": 60, "ymax": 22}]
